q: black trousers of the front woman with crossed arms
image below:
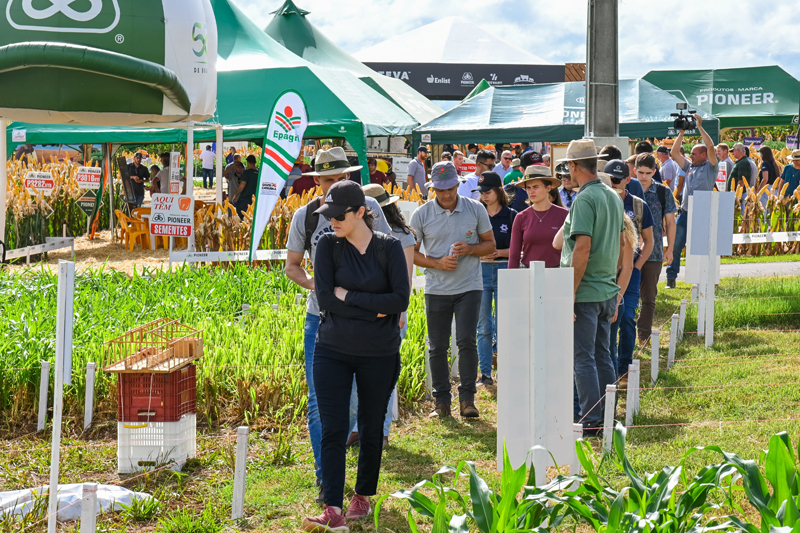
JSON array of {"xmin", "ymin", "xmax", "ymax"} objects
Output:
[{"xmin": 314, "ymin": 345, "xmax": 400, "ymax": 508}]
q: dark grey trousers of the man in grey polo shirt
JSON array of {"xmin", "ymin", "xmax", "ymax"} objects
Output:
[{"xmin": 425, "ymin": 291, "xmax": 483, "ymax": 405}]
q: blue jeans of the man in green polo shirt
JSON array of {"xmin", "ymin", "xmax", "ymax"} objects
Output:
[{"xmin": 574, "ymin": 295, "xmax": 617, "ymax": 428}]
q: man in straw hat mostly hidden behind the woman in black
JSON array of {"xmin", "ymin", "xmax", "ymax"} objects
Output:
[{"xmin": 286, "ymin": 146, "xmax": 392, "ymax": 503}]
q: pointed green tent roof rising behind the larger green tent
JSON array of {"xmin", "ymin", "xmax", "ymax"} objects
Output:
[{"xmin": 264, "ymin": 0, "xmax": 442, "ymax": 124}]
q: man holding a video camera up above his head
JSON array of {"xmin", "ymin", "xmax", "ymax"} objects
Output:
[{"xmin": 667, "ymin": 113, "xmax": 719, "ymax": 289}]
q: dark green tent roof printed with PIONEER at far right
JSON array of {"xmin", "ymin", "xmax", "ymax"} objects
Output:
[{"xmin": 644, "ymin": 66, "xmax": 800, "ymax": 128}]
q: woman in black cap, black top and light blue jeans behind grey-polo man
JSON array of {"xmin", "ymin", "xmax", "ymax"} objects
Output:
[{"xmin": 473, "ymin": 172, "xmax": 517, "ymax": 387}]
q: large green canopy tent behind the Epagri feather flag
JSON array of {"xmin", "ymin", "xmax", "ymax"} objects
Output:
[{"xmin": 8, "ymin": 0, "xmax": 418, "ymax": 184}]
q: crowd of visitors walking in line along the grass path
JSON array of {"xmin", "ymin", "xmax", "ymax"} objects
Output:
[{"xmin": 290, "ymin": 117, "xmax": 741, "ymax": 532}]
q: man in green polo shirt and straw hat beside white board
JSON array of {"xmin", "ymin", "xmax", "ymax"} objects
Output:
[{"xmin": 560, "ymin": 139, "xmax": 625, "ymax": 437}]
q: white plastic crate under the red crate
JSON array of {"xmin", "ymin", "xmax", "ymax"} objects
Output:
[{"xmin": 117, "ymin": 414, "xmax": 197, "ymax": 474}]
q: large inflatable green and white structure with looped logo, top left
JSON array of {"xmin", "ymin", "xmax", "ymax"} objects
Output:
[{"xmin": 0, "ymin": 0, "xmax": 217, "ymax": 126}]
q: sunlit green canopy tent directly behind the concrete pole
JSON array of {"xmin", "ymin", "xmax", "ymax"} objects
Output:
[{"xmin": 414, "ymin": 80, "xmax": 719, "ymax": 146}]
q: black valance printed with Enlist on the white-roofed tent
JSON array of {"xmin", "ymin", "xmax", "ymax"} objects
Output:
[{"xmin": 364, "ymin": 63, "xmax": 565, "ymax": 100}]
